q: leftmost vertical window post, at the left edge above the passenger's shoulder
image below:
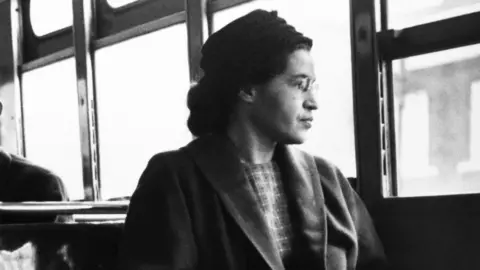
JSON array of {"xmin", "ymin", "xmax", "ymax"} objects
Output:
[{"xmin": 0, "ymin": 0, "xmax": 25, "ymax": 155}]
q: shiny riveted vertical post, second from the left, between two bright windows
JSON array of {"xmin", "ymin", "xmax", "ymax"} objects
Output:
[{"xmin": 72, "ymin": 0, "xmax": 100, "ymax": 201}]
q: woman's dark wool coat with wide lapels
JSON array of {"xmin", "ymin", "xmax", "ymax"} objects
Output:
[{"xmin": 120, "ymin": 135, "xmax": 384, "ymax": 270}]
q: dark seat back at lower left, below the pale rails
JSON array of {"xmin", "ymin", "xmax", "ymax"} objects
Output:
[{"xmin": 0, "ymin": 223, "xmax": 123, "ymax": 270}]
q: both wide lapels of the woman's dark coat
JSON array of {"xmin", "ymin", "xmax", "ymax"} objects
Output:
[{"xmin": 187, "ymin": 135, "xmax": 326, "ymax": 270}]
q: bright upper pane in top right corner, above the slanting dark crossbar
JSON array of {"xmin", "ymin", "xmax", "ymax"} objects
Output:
[{"xmin": 388, "ymin": 0, "xmax": 480, "ymax": 29}]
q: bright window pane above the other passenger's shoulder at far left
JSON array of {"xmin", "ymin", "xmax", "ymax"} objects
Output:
[{"xmin": 22, "ymin": 58, "xmax": 84, "ymax": 199}]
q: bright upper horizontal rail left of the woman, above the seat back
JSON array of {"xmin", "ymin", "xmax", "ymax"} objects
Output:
[{"xmin": 0, "ymin": 201, "xmax": 129, "ymax": 214}]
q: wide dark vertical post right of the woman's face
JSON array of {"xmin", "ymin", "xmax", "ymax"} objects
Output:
[{"xmin": 350, "ymin": 0, "xmax": 383, "ymax": 208}]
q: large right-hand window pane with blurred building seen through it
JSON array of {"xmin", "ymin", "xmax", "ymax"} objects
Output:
[{"xmin": 393, "ymin": 45, "xmax": 480, "ymax": 196}]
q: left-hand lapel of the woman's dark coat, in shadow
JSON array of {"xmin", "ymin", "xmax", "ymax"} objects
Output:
[{"xmin": 187, "ymin": 135, "xmax": 284, "ymax": 270}]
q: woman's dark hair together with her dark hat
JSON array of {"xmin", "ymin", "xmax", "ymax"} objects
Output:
[{"xmin": 187, "ymin": 10, "xmax": 312, "ymax": 136}]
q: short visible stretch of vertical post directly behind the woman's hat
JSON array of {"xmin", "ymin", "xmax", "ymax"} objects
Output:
[{"xmin": 185, "ymin": 0, "xmax": 209, "ymax": 81}]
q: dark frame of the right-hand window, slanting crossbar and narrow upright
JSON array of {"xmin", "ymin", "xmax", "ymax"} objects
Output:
[{"xmin": 376, "ymin": 9, "xmax": 480, "ymax": 198}]
